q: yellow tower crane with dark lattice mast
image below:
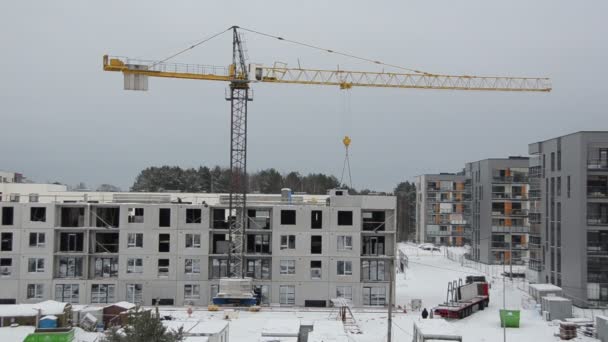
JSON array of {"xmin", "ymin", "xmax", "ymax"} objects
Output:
[{"xmin": 103, "ymin": 26, "xmax": 551, "ymax": 286}]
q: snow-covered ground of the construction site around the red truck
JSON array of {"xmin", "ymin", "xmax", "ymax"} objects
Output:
[{"xmin": 0, "ymin": 244, "xmax": 605, "ymax": 342}]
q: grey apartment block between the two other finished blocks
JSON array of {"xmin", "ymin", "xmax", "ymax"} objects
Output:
[{"xmin": 465, "ymin": 157, "xmax": 530, "ymax": 264}]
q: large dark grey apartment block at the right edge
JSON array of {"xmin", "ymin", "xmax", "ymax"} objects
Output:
[{"xmin": 529, "ymin": 132, "xmax": 608, "ymax": 307}]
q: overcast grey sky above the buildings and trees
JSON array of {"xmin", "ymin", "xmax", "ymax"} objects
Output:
[{"xmin": 0, "ymin": 0, "xmax": 608, "ymax": 190}]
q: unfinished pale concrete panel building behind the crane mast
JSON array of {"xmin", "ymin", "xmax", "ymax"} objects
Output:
[{"xmin": 0, "ymin": 190, "xmax": 396, "ymax": 306}]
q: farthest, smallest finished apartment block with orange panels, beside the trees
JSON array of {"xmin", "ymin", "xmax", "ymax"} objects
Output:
[{"xmin": 416, "ymin": 173, "xmax": 469, "ymax": 246}]
